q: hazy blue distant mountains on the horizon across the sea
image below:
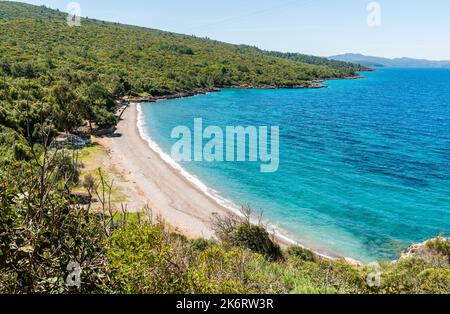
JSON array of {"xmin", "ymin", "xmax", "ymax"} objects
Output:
[{"xmin": 329, "ymin": 53, "xmax": 450, "ymax": 68}]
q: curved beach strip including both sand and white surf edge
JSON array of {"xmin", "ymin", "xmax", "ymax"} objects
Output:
[{"xmin": 106, "ymin": 103, "xmax": 352, "ymax": 263}]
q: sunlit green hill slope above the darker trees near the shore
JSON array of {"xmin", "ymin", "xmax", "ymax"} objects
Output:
[{"xmin": 0, "ymin": 2, "xmax": 364, "ymax": 95}]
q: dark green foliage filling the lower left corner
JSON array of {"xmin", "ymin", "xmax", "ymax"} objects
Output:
[{"xmin": 0, "ymin": 155, "xmax": 108, "ymax": 293}]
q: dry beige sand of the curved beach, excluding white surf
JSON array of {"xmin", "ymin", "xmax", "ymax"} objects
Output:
[{"xmin": 104, "ymin": 104, "xmax": 229, "ymax": 238}]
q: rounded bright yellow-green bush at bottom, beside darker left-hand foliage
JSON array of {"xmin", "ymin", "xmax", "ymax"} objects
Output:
[{"xmin": 107, "ymin": 222, "xmax": 192, "ymax": 294}]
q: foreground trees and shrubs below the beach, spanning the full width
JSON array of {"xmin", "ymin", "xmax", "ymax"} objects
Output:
[{"xmin": 0, "ymin": 148, "xmax": 450, "ymax": 294}]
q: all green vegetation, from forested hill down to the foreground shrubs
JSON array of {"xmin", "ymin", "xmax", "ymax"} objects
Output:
[{"xmin": 0, "ymin": 2, "xmax": 450, "ymax": 293}]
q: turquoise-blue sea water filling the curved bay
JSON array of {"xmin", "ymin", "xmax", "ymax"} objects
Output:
[{"xmin": 142, "ymin": 69, "xmax": 450, "ymax": 261}]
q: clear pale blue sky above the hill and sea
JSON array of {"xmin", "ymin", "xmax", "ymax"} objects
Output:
[{"xmin": 14, "ymin": 0, "xmax": 450, "ymax": 60}]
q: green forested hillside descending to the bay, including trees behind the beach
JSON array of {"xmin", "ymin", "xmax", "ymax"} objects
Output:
[{"xmin": 0, "ymin": 1, "xmax": 368, "ymax": 144}]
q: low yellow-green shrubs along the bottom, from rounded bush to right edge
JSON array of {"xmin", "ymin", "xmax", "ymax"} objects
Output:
[{"xmin": 104, "ymin": 218, "xmax": 450, "ymax": 294}]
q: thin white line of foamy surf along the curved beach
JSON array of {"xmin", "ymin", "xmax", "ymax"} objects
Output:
[{"xmin": 136, "ymin": 103, "xmax": 337, "ymax": 259}]
